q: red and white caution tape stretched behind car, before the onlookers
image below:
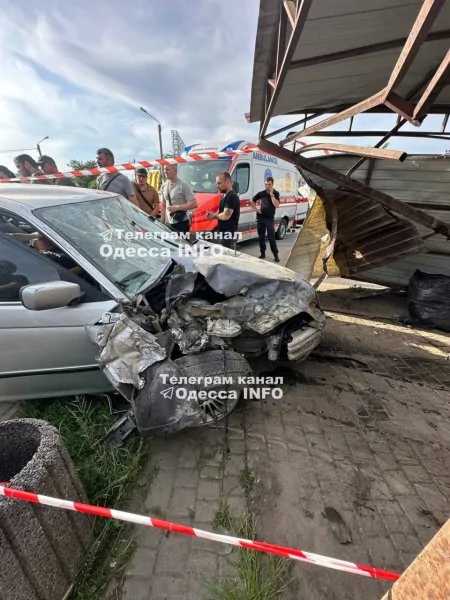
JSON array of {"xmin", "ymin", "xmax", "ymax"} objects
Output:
[{"xmin": 0, "ymin": 147, "xmax": 257, "ymax": 183}]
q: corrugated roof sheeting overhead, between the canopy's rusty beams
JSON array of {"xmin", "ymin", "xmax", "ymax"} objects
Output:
[{"xmin": 250, "ymin": 0, "xmax": 450, "ymax": 122}]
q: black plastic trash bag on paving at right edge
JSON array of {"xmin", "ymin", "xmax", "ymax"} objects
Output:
[{"xmin": 408, "ymin": 269, "xmax": 450, "ymax": 332}]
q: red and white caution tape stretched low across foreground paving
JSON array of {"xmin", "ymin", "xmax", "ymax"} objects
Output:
[{"xmin": 0, "ymin": 484, "xmax": 400, "ymax": 581}]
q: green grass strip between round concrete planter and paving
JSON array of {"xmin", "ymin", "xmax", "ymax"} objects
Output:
[{"xmin": 21, "ymin": 398, "xmax": 149, "ymax": 600}]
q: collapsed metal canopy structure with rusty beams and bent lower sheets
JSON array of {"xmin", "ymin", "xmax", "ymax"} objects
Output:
[{"xmin": 247, "ymin": 0, "xmax": 450, "ymax": 283}]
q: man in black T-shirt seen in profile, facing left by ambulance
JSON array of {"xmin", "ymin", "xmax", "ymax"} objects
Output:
[{"xmin": 206, "ymin": 171, "xmax": 241, "ymax": 248}]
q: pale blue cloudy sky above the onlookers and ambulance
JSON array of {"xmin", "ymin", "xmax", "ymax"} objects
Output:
[{"xmin": 0, "ymin": 0, "xmax": 448, "ymax": 171}]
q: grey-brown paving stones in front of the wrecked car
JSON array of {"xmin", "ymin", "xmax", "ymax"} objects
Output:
[{"xmin": 117, "ymin": 304, "xmax": 450, "ymax": 600}]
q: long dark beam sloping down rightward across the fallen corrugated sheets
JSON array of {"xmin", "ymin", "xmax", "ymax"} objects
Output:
[{"xmin": 258, "ymin": 140, "xmax": 450, "ymax": 240}]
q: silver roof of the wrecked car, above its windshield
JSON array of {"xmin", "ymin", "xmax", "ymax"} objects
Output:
[{"xmin": 0, "ymin": 183, "xmax": 117, "ymax": 210}]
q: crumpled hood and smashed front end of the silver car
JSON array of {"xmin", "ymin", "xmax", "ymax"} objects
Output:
[{"xmin": 87, "ymin": 244, "xmax": 325, "ymax": 389}]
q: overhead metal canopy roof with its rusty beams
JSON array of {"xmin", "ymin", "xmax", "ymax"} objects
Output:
[{"xmin": 249, "ymin": 0, "xmax": 450, "ymax": 142}]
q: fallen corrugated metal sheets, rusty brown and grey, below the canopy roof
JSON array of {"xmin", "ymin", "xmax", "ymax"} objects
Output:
[{"xmin": 306, "ymin": 155, "xmax": 450, "ymax": 285}]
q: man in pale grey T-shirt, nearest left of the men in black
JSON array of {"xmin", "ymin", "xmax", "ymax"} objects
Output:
[{"xmin": 161, "ymin": 165, "xmax": 198, "ymax": 233}]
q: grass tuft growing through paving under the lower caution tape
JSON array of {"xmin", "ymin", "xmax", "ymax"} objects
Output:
[{"xmin": 208, "ymin": 511, "xmax": 292, "ymax": 600}]
